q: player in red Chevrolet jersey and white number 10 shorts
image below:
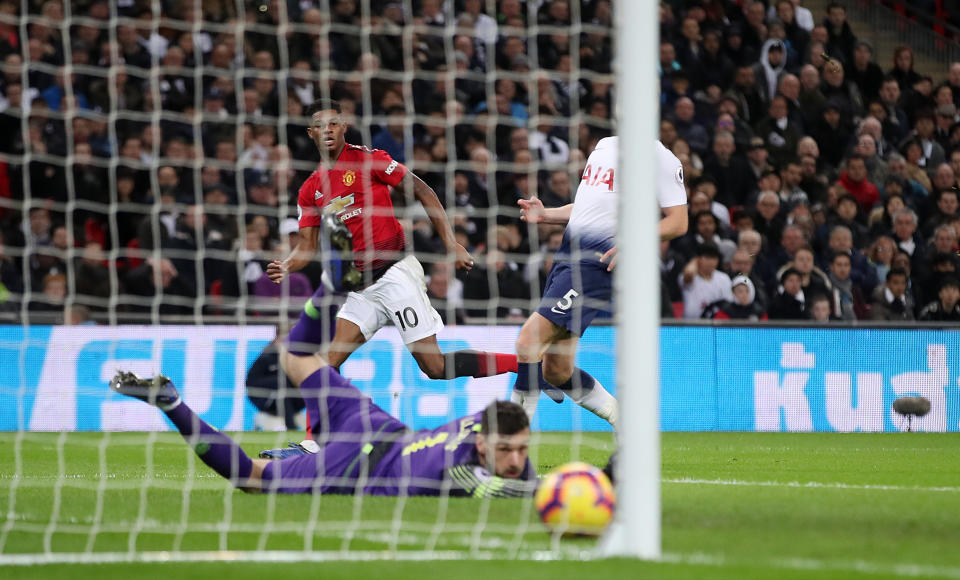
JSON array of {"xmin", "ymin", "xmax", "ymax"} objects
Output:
[{"xmin": 267, "ymin": 99, "xmax": 517, "ymax": 379}]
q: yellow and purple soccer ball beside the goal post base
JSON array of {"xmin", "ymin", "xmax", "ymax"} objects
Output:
[{"xmin": 533, "ymin": 462, "xmax": 616, "ymax": 535}]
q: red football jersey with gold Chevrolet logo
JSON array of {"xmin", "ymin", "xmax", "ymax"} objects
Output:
[{"xmin": 297, "ymin": 143, "xmax": 407, "ymax": 271}]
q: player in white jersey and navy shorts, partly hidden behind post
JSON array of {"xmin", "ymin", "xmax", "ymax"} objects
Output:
[{"xmin": 512, "ymin": 137, "xmax": 687, "ymax": 427}]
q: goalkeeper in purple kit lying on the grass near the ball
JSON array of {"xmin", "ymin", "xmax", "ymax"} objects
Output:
[{"xmin": 110, "ymin": 356, "xmax": 537, "ymax": 497}]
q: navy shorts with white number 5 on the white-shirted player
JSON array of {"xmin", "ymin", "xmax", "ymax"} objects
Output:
[{"xmin": 537, "ymin": 261, "xmax": 613, "ymax": 336}]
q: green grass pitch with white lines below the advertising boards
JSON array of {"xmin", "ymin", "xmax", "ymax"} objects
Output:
[{"xmin": 0, "ymin": 433, "xmax": 960, "ymax": 580}]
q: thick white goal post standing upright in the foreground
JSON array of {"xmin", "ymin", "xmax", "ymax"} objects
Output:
[{"xmin": 599, "ymin": 2, "xmax": 661, "ymax": 559}]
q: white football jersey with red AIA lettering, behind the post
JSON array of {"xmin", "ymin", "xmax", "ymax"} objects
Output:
[{"xmin": 565, "ymin": 137, "xmax": 687, "ymax": 252}]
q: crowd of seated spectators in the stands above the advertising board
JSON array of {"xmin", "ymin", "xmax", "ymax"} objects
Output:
[{"xmin": 0, "ymin": 0, "xmax": 960, "ymax": 323}]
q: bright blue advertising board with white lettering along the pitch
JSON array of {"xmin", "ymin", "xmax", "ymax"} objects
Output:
[{"xmin": 0, "ymin": 326, "xmax": 960, "ymax": 432}]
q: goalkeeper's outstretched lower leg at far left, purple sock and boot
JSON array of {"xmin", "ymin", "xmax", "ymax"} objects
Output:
[{"xmin": 110, "ymin": 372, "xmax": 263, "ymax": 491}]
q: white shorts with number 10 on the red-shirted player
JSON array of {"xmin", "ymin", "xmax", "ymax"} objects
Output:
[{"xmin": 337, "ymin": 256, "xmax": 443, "ymax": 344}]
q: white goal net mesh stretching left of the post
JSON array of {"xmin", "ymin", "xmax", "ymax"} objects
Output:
[{"xmin": 0, "ymin": 0, "xmax": 613, "ymax": 563}]
